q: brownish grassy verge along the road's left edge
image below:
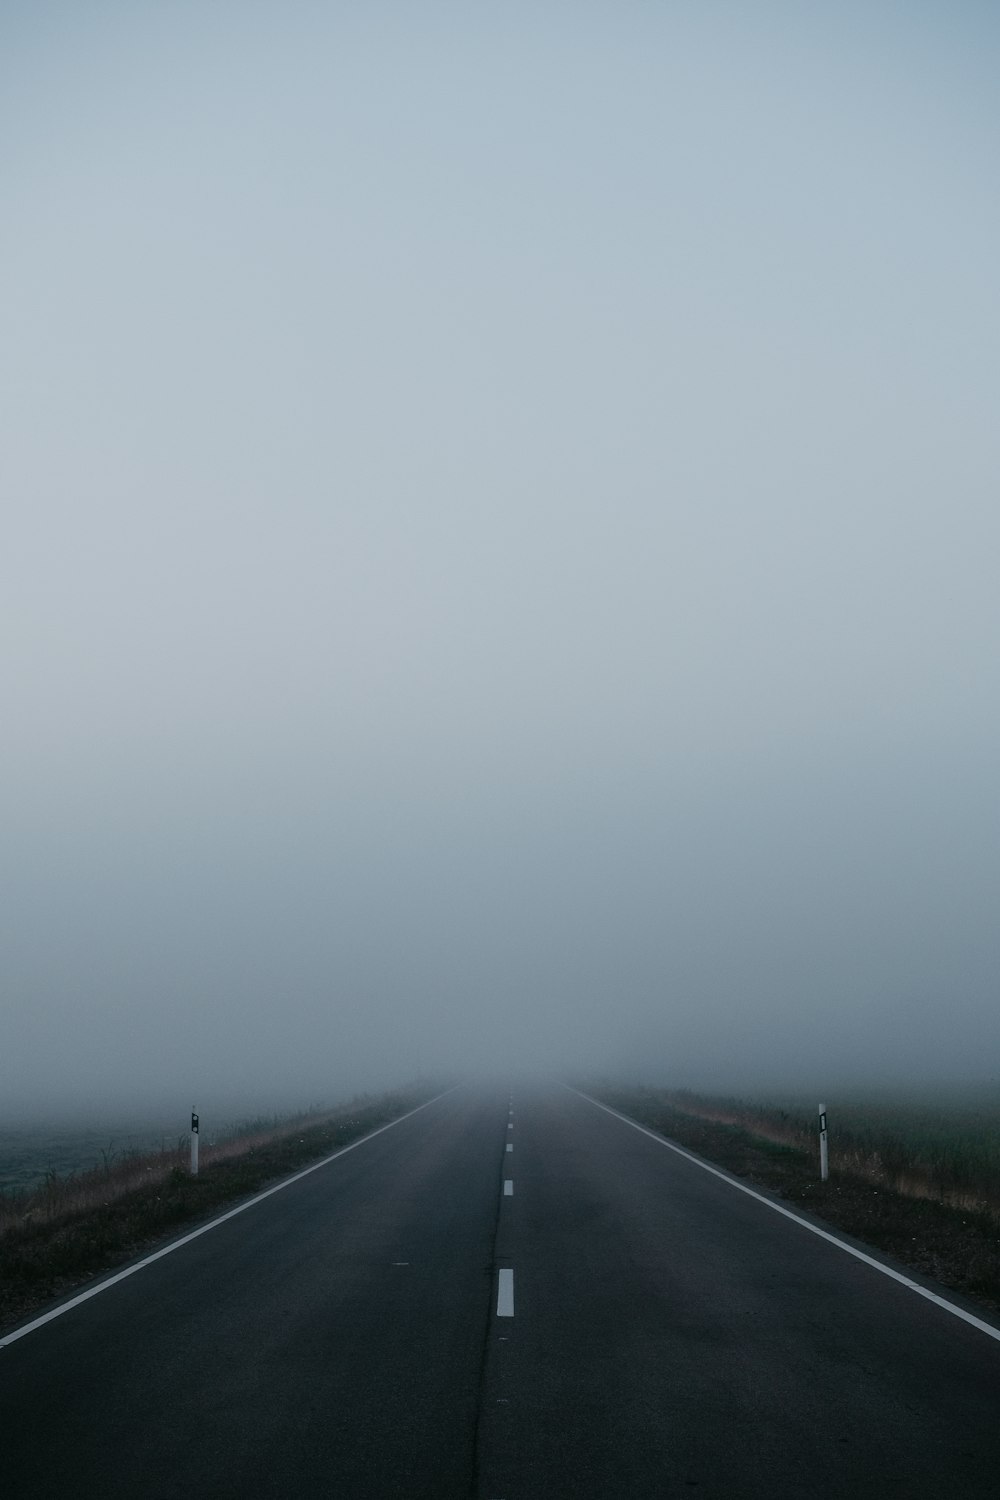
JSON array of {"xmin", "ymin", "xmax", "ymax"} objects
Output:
[{"xmin": 0, "ymin": 1088, "xmax": 435, "ymax": 1328}]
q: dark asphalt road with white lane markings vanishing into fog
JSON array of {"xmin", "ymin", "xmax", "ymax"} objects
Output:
[{"xmin": 0, "ymin": 1088, "xmax": 1000, "ymax": 1500}]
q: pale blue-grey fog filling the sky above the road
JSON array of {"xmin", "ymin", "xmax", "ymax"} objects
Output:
[{"xmin": 0, "ymin": 0, "xmax": 1000, "ymax": 1118}]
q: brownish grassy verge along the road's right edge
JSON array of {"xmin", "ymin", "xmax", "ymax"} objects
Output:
[{"xmin": 586, "ymin": 1085, "xmax": 1000, "ymax": 1313}]
